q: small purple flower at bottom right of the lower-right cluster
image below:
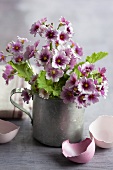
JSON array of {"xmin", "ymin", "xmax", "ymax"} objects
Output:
[{"xmin": 88, "ymin": 92, "xmax": 100, "ymax": 105}]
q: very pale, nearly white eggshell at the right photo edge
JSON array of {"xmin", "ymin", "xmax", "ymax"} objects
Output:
[{"xmin": 89, "ymin": 115, "xmax": 113, "ymax": 148}]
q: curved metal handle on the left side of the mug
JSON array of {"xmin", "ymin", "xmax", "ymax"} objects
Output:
[{"xmin": 10, "ymin": 88, "xmax": 33, "ymax": 124}]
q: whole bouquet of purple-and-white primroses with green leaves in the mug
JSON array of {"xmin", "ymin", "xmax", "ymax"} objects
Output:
[{"xmin": 0, "ymin": 17, "xmax": 108, "ymax": 108}]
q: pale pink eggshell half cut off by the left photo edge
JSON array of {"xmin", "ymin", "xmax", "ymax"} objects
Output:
[{"xmin": 0, "ymin": 119, "xmax": 20, "ymax": 144}]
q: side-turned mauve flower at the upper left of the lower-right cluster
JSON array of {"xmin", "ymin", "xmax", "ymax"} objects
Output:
[{"xmin": 65, "ymin": 73, "xmax": 78, "ymax": 88}]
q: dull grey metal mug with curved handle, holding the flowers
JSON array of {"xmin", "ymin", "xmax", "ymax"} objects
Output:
[{"xmin": 10, "ymin": 88, "xmax": 84, "ymax": 147}]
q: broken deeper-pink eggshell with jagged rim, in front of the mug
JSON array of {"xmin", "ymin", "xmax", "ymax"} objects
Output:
[{"xmin": 62, "ymin": 138, "xmax": 95, "ymax": 163}]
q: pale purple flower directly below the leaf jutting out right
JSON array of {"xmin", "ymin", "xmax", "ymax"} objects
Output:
[{"xmin": 78, "ymin": 62, "xmax": 95, "ymax": 76}]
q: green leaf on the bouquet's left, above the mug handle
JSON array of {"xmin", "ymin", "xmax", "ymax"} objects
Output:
[{"xmin": 9, "ymin": 61, "xmax": 33, "ymax": 81}]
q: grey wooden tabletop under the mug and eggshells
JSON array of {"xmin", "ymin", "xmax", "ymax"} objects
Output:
[{"xmin": 0, "ymin": 119, "xmax": 113, "ymax": 170}]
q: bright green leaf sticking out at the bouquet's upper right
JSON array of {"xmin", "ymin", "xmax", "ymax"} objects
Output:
[{"xmin": 86, "ymin": 52, "xmax": 108, "ymax": 63}]
